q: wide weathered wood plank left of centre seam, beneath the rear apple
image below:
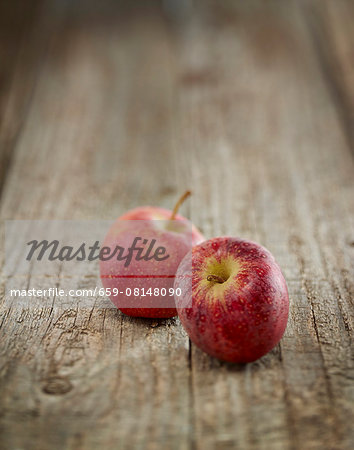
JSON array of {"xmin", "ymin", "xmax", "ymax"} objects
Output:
[{"xmin": 1, "ymin": 2, "xmax": 191, "ymax": 449}]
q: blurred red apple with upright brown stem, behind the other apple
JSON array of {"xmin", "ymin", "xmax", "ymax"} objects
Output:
[{"xmin": 100, "ymin": 192, "xmax": 204, "ymax": 318}]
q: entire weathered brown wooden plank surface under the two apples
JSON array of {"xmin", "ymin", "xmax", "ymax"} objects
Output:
[{"xmin": 0, "ymin": 0, "xmax": 354, "ymax": 450}]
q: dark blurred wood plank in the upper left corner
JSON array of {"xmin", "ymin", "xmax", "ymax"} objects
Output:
[{"xmin": 0, "ymin": 0, "xmax": 60, "ymax": 197}]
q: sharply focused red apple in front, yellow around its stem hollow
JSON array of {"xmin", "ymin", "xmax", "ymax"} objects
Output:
[{"xmin": 175, "ymin": 236, "xmax": 289, "ymax": 363}]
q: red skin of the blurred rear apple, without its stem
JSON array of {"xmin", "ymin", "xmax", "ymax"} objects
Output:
[{"xmin": 100, "ymin": 206, "xmax": 204, "ymax": 318}]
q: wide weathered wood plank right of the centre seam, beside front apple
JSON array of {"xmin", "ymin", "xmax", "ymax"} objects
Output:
[{"xmin": 176, "ymin": 2, "xmax": 354, "ymax": 448}]
